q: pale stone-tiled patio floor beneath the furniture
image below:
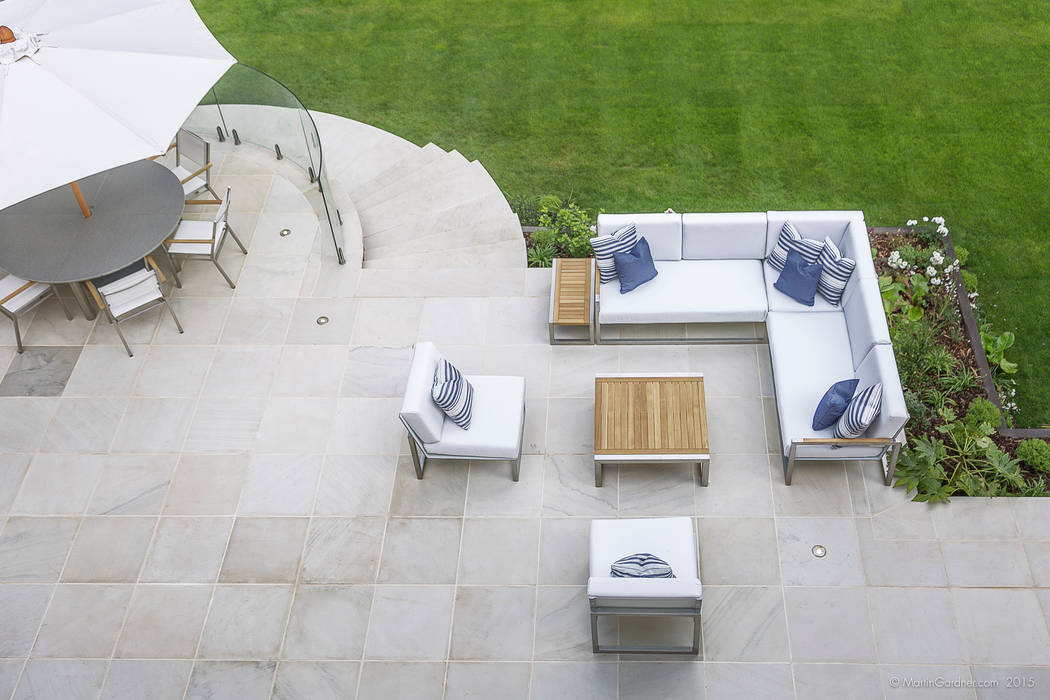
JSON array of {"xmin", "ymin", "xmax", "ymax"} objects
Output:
[{"xmin": 0, "ymin": 138, "xmax": 1050, "ymax": 700}]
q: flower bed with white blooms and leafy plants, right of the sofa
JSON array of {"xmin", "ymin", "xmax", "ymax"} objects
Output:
[{"xmin": 872, "ymin": 217, "xmax": 1050, "ymax": 501}]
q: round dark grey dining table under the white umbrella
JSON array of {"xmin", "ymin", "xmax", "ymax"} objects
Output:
[{"xmin": 0, "ymin": 161, "xmax": 186, "ymax": 318}]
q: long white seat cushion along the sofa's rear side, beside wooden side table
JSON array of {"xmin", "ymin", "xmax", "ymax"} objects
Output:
[{"xmin": 599, "ymin": 260, "xmax": 779, "ymax": 324}]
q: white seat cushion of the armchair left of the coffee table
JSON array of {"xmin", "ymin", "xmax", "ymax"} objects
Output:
[{"xmin": 426, "ymin": 375, "xmax": 525, "ymax": 460}]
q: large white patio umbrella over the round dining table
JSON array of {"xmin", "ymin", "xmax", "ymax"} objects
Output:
[{"xmin": 0, "ymin": 0, "xmax": 236, "ymax": 216}]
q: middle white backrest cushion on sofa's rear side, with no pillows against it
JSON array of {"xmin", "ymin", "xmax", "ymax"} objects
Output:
[{"xmin": 681, "ymin": 212, "xmax": 765, "ymax": 260}]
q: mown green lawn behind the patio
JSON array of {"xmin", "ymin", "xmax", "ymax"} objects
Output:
[{"xmin": 195, "ymin": 0, "xmax": 1050, "ymax": 425}]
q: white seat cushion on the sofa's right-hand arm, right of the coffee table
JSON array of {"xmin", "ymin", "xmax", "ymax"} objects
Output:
[{"xmin": 765, "ymin": 312, "xmax": 856, "ymax": 454}]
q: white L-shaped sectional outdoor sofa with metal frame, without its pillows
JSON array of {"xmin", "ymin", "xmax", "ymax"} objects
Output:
[{"xmin": 594, "ymin": 211, "xmax": 908, "ymax": 485}]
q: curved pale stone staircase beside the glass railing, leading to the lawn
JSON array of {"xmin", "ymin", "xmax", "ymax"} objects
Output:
[{"xmin": 310, "ymin": 115, "xmax": 526, "ymax": 270}]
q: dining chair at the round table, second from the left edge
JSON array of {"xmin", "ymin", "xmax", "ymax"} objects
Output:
[{"xmin": 85, "ymin": 255, "xmax": 183, "ymax": 357}]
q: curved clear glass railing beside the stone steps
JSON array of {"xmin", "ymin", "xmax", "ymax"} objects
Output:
[{"xmin": 184, "ymin": 63, "xmax": 345, "ymax": 264}]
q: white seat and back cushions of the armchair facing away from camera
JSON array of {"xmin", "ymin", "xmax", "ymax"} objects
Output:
[{"xmin": 587, "ymin": 517, "xmax": 701, "ymax": 598}]
